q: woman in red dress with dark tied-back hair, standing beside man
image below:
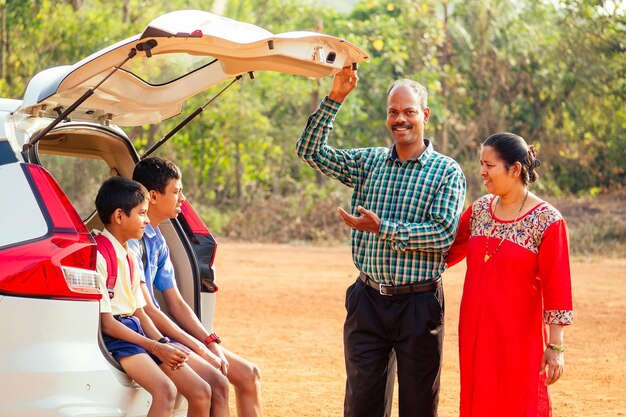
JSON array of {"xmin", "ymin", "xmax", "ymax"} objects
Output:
[{"xmin": 447, "ymin": 132, "xmax": 572, "ymax": 417}]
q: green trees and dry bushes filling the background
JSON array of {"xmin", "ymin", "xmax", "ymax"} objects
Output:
[{"xmin": 0, "ymin": 0, "xmax": 626, "ymax": 255}]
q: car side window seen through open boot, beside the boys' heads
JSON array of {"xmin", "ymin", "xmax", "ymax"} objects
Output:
[{"xmin": 38, "ymin": 152, "xmax": 110, "ymax": 221}]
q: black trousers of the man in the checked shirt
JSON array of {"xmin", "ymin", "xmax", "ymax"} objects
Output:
[{"xmin": 343, "ymin": 278, "xmax": 444, "ymax": 417}]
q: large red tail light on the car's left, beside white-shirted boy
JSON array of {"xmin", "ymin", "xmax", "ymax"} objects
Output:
[{"xmin": 0, "ymin": 164, "xmax": 102, "ymax": 300}]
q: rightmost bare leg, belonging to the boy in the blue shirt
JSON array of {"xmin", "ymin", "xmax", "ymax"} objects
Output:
[{"xmin": 222, "ymin": 347, "xmax": 263, "ymax": 417}]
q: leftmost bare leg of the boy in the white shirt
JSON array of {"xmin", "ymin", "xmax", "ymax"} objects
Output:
[{"xmin": 120, "ymin": 353, "xmax": 176, "ymax": 417}]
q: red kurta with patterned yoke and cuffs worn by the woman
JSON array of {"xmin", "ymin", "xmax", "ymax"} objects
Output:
[{"xmin": 447, "ymin": 195, "xmax": 572, "ymax": 417}]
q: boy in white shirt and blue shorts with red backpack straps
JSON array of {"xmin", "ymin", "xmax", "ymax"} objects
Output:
[{"xmin": 96, "ymin": 177, "xmax": 211, "ymax": 417}]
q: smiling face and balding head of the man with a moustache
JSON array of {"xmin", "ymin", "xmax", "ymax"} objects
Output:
[{"xmin": 387, "ymin": 86, "xmax": 430, "ymax": 146}]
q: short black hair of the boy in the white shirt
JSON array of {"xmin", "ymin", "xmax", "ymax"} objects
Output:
[{"xmin": 96, "ymin": 177, "xmax": 149, "ymax": 225}]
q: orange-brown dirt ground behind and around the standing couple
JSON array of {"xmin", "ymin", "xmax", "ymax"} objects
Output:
[{"xmin": 215, "ymin": 242, "xmax": 626, "ymax": 417}]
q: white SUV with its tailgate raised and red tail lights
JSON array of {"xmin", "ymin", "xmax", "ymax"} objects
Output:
[{"xmin": 0, "ymin": 10, "xmax": 367, "ymax": 417}]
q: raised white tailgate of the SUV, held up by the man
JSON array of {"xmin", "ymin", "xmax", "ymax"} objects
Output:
[{"xmin": 19, "ymin": 10, "xmax": 368, "ymax": 126}]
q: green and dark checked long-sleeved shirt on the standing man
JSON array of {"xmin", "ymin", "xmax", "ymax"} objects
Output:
[{"xmin": 296, "ymin": 98, "xmax": 465, "ymax": 285}]
